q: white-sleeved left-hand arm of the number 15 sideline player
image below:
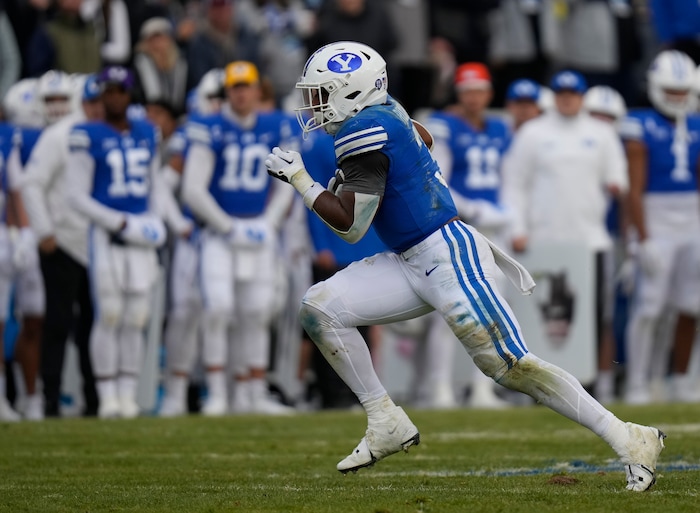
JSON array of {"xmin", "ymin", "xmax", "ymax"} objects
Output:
[{"xmin": 66, "ymin": 132, "xmax": 126, "ymax": 232}]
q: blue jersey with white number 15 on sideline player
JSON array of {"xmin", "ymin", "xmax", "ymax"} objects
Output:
[{"xmin": 69, "ymin": 121, "xmax": 158, "ymax": 214}]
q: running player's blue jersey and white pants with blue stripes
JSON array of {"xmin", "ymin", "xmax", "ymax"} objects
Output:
[{"xmin": 302, "ymin": 99, "xmax": 534, "ymax": 379}]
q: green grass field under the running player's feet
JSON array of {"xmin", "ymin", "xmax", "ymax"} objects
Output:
[{"xmin": 0, "ymin": 405, "xmax": 700, "ymax": 513}]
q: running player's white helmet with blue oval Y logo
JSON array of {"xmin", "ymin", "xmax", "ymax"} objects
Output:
[{"xmin": 296, "ymin": 41, "xmax": 388, "ymax": 134}]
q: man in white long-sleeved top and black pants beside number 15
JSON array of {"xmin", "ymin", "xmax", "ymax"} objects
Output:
[{"xmin": 22, "ymin": 75, "xmax": 103, "ymax": 417}]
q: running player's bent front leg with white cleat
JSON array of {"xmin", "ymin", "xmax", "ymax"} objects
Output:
[{"xmin": 300, "ymin": 253, "xmax": 432, "ymax": 472}]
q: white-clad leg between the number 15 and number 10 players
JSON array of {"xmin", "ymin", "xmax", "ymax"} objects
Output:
[{"xmin": 159, "ymin": 238, "xmax": 202, "ymax": 417}]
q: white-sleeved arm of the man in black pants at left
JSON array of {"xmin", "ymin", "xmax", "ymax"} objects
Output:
[{"xmin": 21, "ymin": 130, "xmax": 60, "ymax": 240}]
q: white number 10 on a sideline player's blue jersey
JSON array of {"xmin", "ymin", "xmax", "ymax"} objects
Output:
[{"xmin": 219, "ymin": 144, "xmax": 270, "ymax": 192}]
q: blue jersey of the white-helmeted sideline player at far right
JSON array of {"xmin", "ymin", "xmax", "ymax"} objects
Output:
[{"xmin": 620, "ymin": 109, "xmax": 700, "ymax": 193}]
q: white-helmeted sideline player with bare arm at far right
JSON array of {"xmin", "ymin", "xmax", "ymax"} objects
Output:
[{"xmin": 620, "ymin": 50, "xmax": 700, "ymax": 404}]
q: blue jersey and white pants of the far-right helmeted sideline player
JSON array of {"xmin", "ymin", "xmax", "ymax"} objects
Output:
[{"xmin": 620, "ymin": 109, "xmax": 700, "ymax": 316}]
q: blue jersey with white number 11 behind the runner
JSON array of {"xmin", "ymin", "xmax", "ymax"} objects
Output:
[{"xmin": 429, "ymin": 112, "xmax": 511, "ymax": 204}]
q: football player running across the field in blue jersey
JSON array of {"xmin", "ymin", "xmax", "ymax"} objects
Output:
[{"xmin": 266, "ymin": 42, "xmax": 665, "ymax": 491}]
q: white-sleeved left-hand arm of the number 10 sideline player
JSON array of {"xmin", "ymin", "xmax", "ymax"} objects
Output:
[{"xmin": 182, "ymin": 143, "xmax": 233, "ymax": 233}]
